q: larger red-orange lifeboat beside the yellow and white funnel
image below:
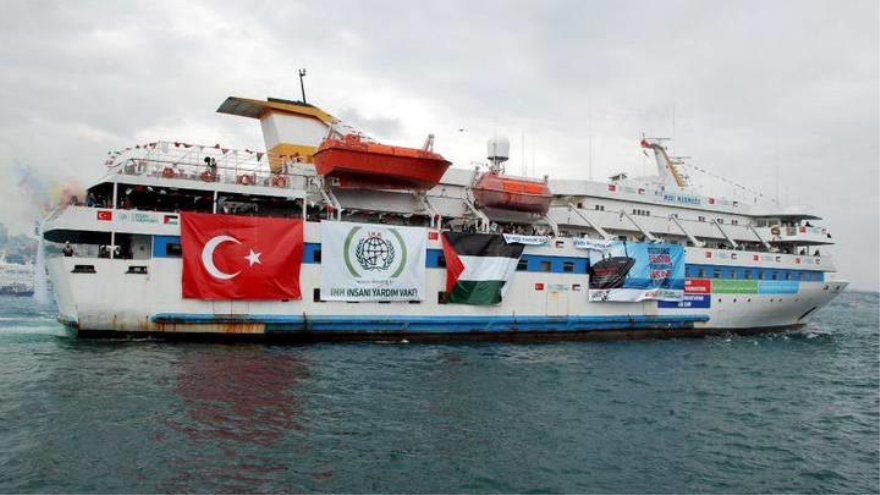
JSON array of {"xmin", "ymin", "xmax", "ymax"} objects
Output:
[{"xmin": 314, "ymin": 134, "xmax": 450, "ymax": 190}]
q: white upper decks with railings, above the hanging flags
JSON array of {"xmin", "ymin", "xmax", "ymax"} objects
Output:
[{"xmin": 47, "ymin": 142, "xmax": 833, "ymax": 268}]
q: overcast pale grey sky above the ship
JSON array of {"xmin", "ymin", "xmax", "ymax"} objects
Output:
[{"xmin": 0, "ymin": 0, "xmax": 880, "ymax": 290}]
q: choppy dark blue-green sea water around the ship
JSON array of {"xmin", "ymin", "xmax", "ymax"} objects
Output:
[{"xmin": 0, "ymin": 293, "xmax": 880, "ymax": 493}]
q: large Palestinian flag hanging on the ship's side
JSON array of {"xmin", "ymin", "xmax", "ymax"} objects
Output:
[{"xmin": 443, "ymin": 232, "xmax": 525, "ymax": 305}]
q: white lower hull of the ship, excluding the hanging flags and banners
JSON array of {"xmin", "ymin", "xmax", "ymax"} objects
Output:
[{"xmin": 48, "ymin": 224, "xmax": 846, "ymax": 340}]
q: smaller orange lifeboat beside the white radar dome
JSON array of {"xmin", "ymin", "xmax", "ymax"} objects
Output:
[{"xmin": 474, "ymin": 172, "xmax": 553, "ymax": 215}]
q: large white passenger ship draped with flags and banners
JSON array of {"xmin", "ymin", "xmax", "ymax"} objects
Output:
[{"xmin": 43, "ymin": 97, "xmax": 848, "ymax": 342}]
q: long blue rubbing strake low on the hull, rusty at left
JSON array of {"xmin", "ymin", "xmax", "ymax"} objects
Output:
[{"xmin": 151, "ymin": 313, "xmax": 709, "ymax": 334}]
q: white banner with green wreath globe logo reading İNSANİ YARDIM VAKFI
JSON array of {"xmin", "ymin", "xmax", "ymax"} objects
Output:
[{"xmin": 321, "ymin": 222, "xmax": 428, "ymax": 301}]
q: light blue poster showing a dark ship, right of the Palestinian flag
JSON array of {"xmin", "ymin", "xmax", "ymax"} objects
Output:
[{"xmin": 589, "ymin": 241, "xmax": 685, "ymax": 302}]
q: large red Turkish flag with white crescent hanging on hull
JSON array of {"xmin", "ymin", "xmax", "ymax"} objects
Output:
[{"xmin": 180, "ymin": 212, "xmax": 303, "ymax": 300}]
